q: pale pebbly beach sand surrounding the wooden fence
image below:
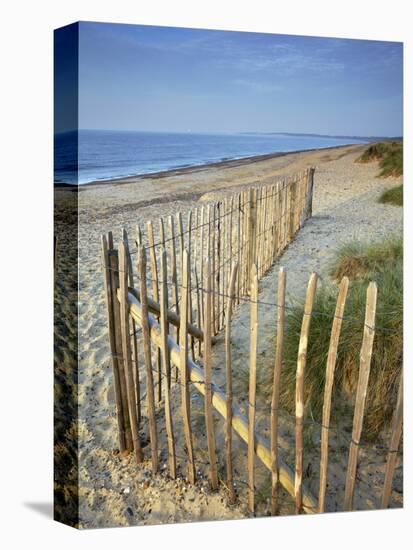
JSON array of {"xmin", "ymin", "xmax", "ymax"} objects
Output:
[{"xmin": 56, "ymin": 145, "xmax": 402, "ymax": 528}]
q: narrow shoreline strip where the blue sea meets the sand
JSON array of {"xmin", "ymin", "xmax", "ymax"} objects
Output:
[{"xmin": 54, "ymin": 143, "xmax": 368, "ymax": 190}]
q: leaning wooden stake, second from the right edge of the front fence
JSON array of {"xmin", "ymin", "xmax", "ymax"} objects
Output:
[{"xmin": 344, "ymin": 282, "xmax": 377, "ymax": 512}]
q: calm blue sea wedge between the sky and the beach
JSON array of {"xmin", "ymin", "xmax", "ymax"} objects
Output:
[{"xmin": 54, "ymin": 130, "xmax": 368, "ymax": 185}]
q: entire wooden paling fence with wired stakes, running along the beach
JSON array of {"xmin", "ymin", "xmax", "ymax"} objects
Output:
[{"xmin": 102, "ymin": 169, "xmax": 403, "ymax": 514}]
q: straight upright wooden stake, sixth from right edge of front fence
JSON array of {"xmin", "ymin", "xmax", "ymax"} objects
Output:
[{"xmin": 248, "ymin": 263, "xmax": 258, "ymax": 514}]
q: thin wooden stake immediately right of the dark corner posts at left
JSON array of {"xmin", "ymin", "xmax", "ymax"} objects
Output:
[{"xmin": 119, "ymin": 242, "xmax": 143, "ymax": 463}]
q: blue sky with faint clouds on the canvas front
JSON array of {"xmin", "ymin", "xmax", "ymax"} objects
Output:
[{"xmin": 73, "ymin": 23, "xmax": 403, "ymax": 136}]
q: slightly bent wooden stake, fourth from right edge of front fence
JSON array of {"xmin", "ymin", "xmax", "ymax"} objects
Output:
[{"xmin": 294, "ymin": 273, "xmax": 317, "ymax": 514}]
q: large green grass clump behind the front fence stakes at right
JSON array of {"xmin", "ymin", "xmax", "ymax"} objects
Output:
[{"xmin": 263, "ymin": 239, "xmax": 403, "ymax": 439}]
